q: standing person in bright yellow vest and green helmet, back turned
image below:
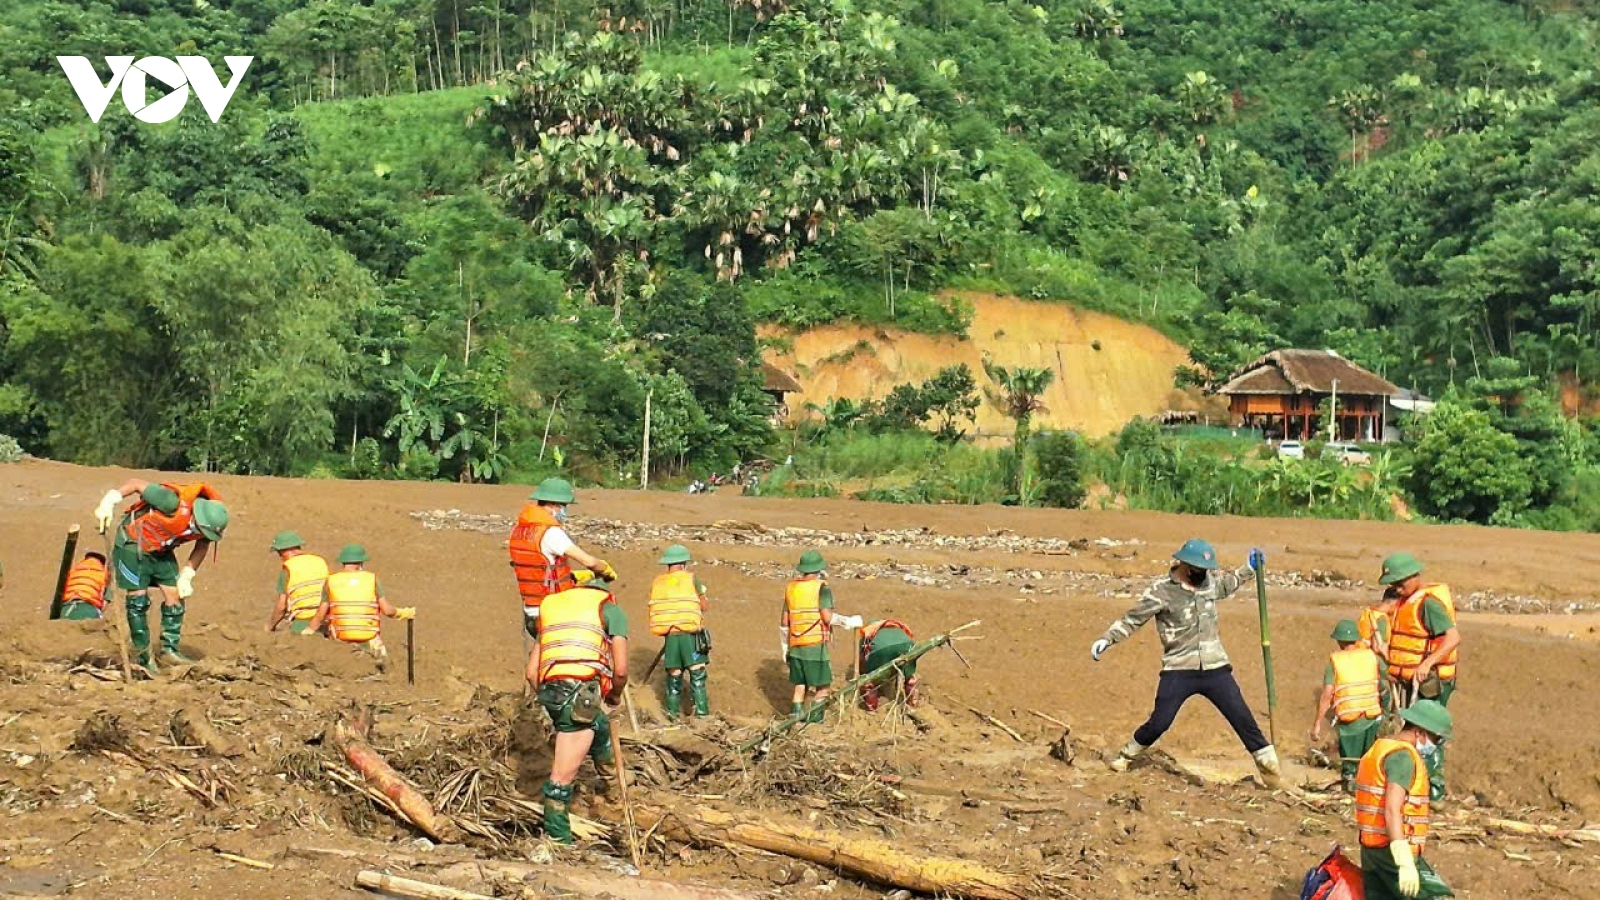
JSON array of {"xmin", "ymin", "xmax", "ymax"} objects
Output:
[{"xmin": 650, "ymin": 544, "xmax": 710, "ymax": 722}]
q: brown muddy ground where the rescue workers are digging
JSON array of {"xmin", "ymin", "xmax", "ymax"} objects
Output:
[{"xmin": 0, "ymin": 461, "xmax": 1600, "ymax": 900}]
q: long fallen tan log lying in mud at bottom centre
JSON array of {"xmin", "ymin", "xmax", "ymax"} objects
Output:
[{"xmin": 604, "ymin": 806, "xmax": 1027, "ymax": 900}]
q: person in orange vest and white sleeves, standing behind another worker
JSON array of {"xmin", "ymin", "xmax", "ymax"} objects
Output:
[{"xmin": 507, "ymin": 479, "xmax": 616, "ymax": 637}]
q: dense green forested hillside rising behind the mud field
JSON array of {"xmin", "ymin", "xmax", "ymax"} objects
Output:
[{"xmin": 0, "ymin": 0, "xmax": 1600, "ymax": 520}]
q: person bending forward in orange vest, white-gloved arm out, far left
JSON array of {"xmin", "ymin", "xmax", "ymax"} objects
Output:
[{"xmin": 94, "ymin": 479, "xmax": 227, "ymax": 676}]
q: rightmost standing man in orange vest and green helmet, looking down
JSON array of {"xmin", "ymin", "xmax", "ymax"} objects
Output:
[{"xmin": 1378, "ymin": 552, "xmax": 1461, "ymax": 801}]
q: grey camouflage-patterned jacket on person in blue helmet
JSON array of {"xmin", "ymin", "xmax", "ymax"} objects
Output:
[{"xmin": 1104, "ymin": 565, "xmax": 1256, "ymax": 673}]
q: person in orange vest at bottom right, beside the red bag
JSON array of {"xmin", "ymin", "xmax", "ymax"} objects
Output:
[{"xmin": 1355, "ymin": 700, "xmax": 1451, "ymax": 900}]
